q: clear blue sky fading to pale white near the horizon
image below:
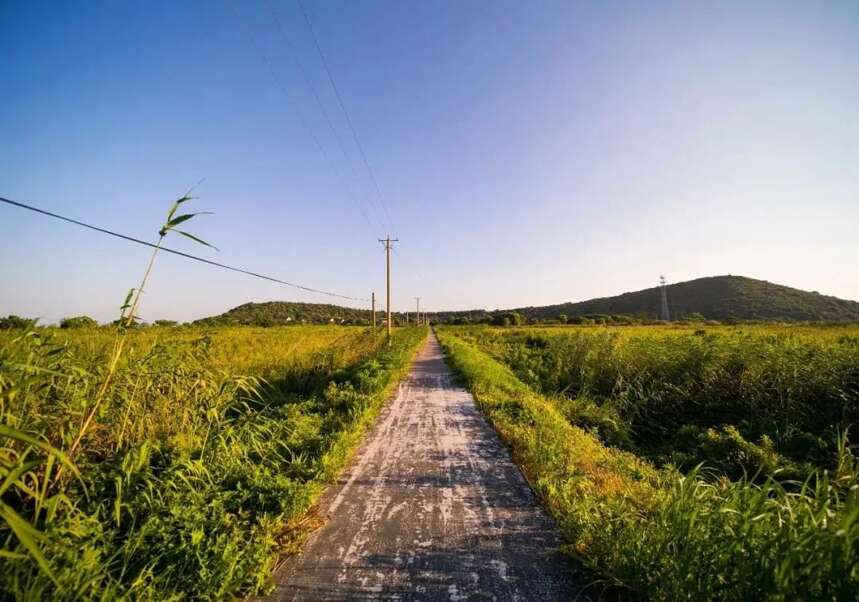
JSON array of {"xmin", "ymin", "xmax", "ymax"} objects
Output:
[{"xmin": 0, "ymin": 0, "xmax": 859, "ymax": 321}]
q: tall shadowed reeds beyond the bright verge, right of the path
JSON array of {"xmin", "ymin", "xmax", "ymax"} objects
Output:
[{"xmin": 450, "ymin": 327, "xmax": 859, "ymax": 478}]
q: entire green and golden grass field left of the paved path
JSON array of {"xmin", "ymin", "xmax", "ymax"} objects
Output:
[{"xmin": 0, "ymin": 326, "xmax": 426, "ymax": 600}]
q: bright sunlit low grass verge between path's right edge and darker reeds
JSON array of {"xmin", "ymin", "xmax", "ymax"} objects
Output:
[{"xmin": 437, "ymin": 327, "xmax": 859, "ymax": 601}]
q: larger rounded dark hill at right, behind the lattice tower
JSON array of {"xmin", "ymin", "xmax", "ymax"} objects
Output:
[{"xmin": 508, "ymin": 276, "xmax": 859, "ymax": 322}]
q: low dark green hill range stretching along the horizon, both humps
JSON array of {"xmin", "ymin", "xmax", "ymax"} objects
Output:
[{"xmin": 196, "ymin": 276, "xmax": 859, "ymax": 326}]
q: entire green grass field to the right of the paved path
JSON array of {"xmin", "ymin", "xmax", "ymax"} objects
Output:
[{"xmin": 437, "ymin": 326, "xmax": 859, "ymax": 600}]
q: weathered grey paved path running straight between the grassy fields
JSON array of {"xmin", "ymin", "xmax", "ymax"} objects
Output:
[{"xmin": 262, "ymin": 334, "xmax": 581, "ymax": 600}]
